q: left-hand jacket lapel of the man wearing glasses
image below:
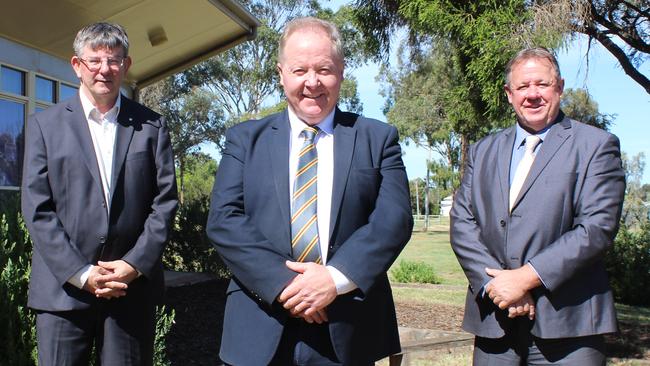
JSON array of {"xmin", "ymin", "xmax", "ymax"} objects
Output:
[{"xmin": 66, "ymin": 96, "xmax": 104, "ymax": 197}]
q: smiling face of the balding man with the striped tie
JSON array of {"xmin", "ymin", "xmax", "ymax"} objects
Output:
[{"xmin": 278, "ymin": 28, "xmax": 343, "ymax": 125}]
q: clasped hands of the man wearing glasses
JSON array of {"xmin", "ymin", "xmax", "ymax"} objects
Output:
[{"xmin": 84, "ymin": 260, "xmax": 138, "ymax": 299}]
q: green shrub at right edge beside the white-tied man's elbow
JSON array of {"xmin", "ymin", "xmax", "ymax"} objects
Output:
[{"xmin": 605, "ymin": 221, "xmax": 650, "ymax": 306}]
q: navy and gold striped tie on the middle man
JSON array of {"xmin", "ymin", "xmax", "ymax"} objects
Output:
[{"xmin": 291, "ymin": 127, "xmax": 321, "ymax": 263}]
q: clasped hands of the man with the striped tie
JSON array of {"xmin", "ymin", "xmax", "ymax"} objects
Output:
[{"xmin": 278, "ymin": 261, "xmax": 337, "ymax": 324}]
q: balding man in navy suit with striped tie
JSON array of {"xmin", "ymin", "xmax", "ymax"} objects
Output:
[{"xmin": 207, "ymin": 18, "xmax": 413, "ymax": 366}]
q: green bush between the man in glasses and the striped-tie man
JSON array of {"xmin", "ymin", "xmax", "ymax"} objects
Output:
[{"xmin": 163, "ymin": 154, "xmax": 229, "ymax": 276}]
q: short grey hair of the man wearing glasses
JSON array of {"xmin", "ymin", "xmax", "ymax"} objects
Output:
[{"xmin": 72, "ymin": 22, "xmax": 129, "ymax": 57}]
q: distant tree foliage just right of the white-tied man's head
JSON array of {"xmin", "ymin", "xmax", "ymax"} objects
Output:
[{"xmin": 560, "ymin": 89, "xmax": 615, "ymax": 131}]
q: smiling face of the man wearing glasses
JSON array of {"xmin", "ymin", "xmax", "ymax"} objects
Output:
[{"xmin": 70, "ymin": 46, "xmax": 131, "ymax": 113}]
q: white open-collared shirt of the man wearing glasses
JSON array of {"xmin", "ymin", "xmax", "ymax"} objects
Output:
[{"xmin": 68, "ymin": 90, "xmax": 121, "ymax": 288}]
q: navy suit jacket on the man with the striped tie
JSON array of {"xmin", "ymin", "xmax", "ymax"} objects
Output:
[{"xmin": 207, "ymin": 110, "xmax": 413, "ymax": 365}]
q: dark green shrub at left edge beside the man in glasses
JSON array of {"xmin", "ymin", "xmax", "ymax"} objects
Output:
[{"xmin": 0, "ymin": 192, "xmax": 37, "ymax": 366}]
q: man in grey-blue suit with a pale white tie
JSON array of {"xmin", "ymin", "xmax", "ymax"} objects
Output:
[{"xmin": 451, "ymin": 48, "xmax": 625, "ymax": 365}]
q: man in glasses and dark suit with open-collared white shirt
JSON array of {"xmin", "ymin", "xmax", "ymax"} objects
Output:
[{"xmin": 22, "ymin": 23, "xmax": 177, "ymax": 366}]
